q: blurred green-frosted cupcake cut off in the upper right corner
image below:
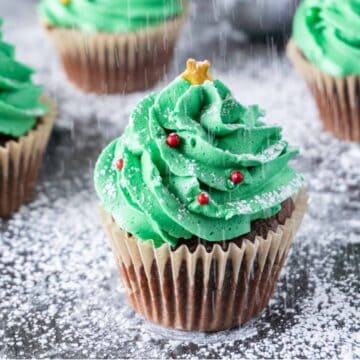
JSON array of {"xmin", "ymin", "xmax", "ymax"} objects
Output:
[{"xmin": 287, "ymin": 0, "xmax": 360, "ymax": 142}]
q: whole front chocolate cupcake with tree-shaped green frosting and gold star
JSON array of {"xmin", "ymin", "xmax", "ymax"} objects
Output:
[{"xmin": 94, "ymin": 60, "xmax": 306, "ymax": 331}]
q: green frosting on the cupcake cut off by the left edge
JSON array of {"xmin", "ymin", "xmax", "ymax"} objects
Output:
[{"xmin": 0, "ymin": 18, "xmax": 47, "ymax": 138}]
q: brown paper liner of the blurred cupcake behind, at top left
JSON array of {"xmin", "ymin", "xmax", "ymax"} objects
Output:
[{"xmin": 45, "ymin": 15, "xmax": 185, "ymax": 94}]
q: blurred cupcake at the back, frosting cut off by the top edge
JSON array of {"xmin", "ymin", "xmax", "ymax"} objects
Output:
[{"xmin": 38, "ymin": 0, "xmax": 186, "ymax": 93}]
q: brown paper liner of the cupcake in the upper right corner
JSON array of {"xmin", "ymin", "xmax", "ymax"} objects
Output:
[{"xmin": 287, "ymin": 40, "xmax": 360, "ymax": 142}]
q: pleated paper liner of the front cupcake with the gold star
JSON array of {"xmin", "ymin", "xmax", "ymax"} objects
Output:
[{"xmin": 100, "ymin": 190, "xmax": 307, "ymax": 331}]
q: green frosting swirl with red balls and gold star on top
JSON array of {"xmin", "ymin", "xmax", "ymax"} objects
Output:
[{"xmin": 95, "ymin": 60, "xmax": 302, "ymax": 246}]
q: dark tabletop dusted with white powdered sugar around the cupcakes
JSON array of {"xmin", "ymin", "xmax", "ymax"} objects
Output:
[{"xmin": 0, "ymin": 0, "xmax": 360, "ymax": 359}]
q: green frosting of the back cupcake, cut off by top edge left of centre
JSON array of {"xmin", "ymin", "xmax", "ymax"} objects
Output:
[{"xmin": 38, "ymin": 0, "xmax": 183, "ymax": 32}]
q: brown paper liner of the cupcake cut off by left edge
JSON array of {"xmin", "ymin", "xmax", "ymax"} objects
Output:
[{"xmin": 0, "ymin": 98, "xmax": 55, "ymax": 217}]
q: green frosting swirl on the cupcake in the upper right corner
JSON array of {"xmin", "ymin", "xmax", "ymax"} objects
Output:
[{"xmin": 292, "ymin": 0, "xmax": 360, "ymax": 77}]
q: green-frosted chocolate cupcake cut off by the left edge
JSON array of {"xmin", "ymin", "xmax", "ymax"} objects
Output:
[{"xmin": 0, "ymin": 19, "xmax": 54, "ymax": 217}]
